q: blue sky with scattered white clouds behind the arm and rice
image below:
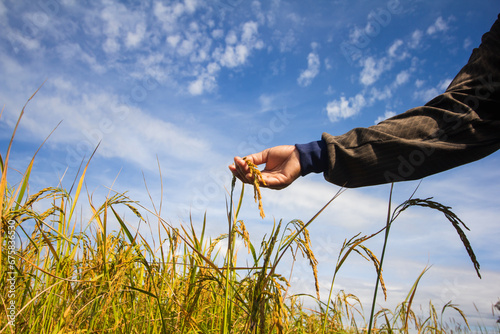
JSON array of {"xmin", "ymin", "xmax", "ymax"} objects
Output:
[{"xmin": 0, "ymin": 0, "xmax": 500, "ymax": 328}]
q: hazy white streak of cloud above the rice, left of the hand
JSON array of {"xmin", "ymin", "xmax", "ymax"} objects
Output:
[{"xmin": 17, "ymin": 78, "xmax": 209, "ymax": 170}]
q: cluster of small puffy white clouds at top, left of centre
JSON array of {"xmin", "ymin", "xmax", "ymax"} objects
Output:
[{"xmin": 87, "ymin": 4, "xmax": 264, "ymax": 95}]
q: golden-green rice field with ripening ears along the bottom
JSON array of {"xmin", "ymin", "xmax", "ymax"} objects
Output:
[{"xmin": 0, "ymin": 92, "xmax": 498, "ymax": 334}]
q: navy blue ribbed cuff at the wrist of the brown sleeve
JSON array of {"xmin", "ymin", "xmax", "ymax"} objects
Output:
[{"xmin": 295, "ymin": 140, "xmax": 328, "ymax": 176}]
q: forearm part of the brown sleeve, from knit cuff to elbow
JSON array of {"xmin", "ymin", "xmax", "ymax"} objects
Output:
[{"xmin": 323, "ymin": 96, "xmax": 500, "ymax": 187}]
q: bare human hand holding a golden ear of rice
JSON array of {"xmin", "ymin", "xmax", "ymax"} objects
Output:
[{"xmin": 229, "ymin": 145, "xmax": 300, "ymax": 189}]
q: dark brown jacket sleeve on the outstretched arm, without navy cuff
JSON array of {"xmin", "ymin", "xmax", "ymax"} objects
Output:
[{"xmin": 322, "ymin": 15, "xmax": 500, "ymax": 187}]
